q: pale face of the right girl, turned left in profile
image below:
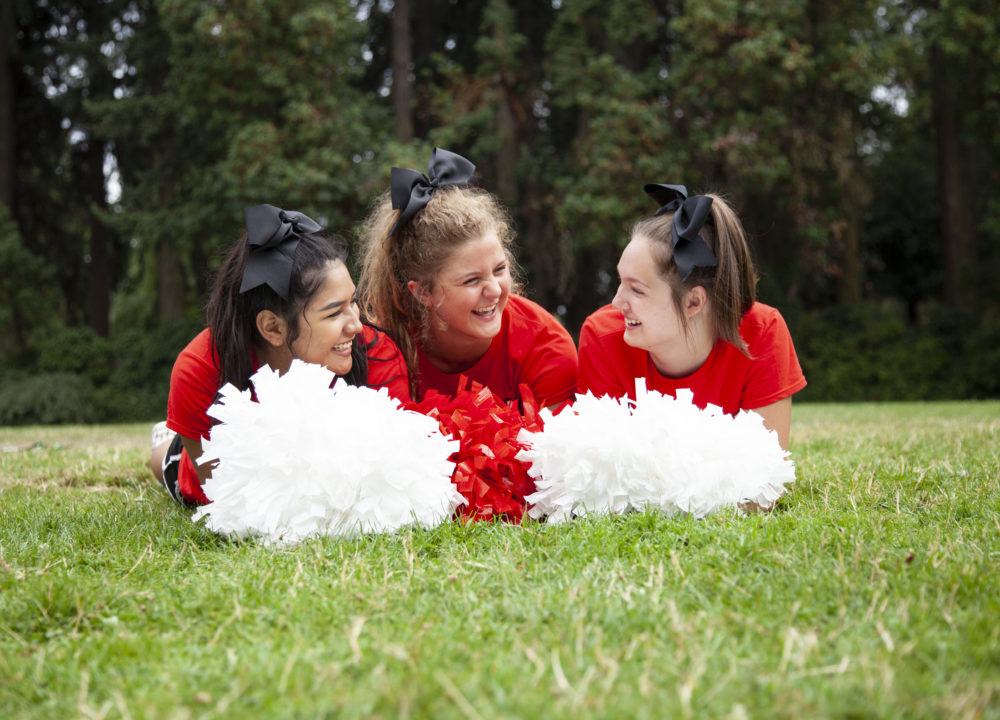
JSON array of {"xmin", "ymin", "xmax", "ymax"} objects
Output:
[{"xmin": 611, "ymin": 235, "xmax": 686, "ymax": 355}]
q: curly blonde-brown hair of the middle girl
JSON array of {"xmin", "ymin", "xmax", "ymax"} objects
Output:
[{"xmin": 358, "ymin": 185, "xmax": 518, "ymax": 397}]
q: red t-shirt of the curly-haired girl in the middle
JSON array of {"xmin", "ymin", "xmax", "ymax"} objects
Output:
[{"xmin": 417, "ymin": 295, "xmax": 577, "ymax": 407}]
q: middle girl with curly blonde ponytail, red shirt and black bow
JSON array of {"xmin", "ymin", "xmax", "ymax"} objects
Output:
[{"xmin": 358, "ymin": 148, "xmax": 577, "ymax": 406}]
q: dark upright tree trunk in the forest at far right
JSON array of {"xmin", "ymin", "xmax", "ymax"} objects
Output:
[{"xmin": 931, "ymin": 45, "xmax": 973, "ymax": 307}]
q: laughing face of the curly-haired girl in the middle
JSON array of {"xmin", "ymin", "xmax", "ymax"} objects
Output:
[{"xmin": 422, "ymin": 230, "xmax": 511, "ymax": 342}]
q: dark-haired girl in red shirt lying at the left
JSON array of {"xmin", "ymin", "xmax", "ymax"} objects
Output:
[{"xmin": 150, "ymin": 205, "xmax": 410, "ymax": 504}]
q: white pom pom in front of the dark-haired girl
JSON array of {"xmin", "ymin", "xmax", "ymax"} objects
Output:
[{"xmin": 194, "ymin": 360, "xmax": 463, "ymax": 544}]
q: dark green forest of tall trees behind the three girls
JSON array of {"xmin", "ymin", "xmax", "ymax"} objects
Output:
[{"xmin": 0, "ymin": 0, "xmax": 1000, "ymax": 424}]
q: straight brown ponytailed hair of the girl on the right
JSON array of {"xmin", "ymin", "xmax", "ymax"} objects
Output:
[{"xmin": 631, "ymin": 193, "xmax": 757, "ymax": 356}]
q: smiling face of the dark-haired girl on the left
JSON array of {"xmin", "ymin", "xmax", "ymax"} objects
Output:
[{"xmin": 291, "ymin": 260, "xmax": 361, "ymax": 375}]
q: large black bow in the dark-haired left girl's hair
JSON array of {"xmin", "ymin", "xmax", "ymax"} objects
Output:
[{"xmin": 240, "ymin": 205, "xmax": 323, "ymax": 300}]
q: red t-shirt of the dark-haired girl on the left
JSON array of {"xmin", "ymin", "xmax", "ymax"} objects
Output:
[{"xmin": 167, "ymin": 325, "xmax": 410, "ymax": 504}]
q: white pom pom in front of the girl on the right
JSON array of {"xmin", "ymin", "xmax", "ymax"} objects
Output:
[{"xmin": 518, "ymin": 378, "xmax": 795, "ymax": 522}]
